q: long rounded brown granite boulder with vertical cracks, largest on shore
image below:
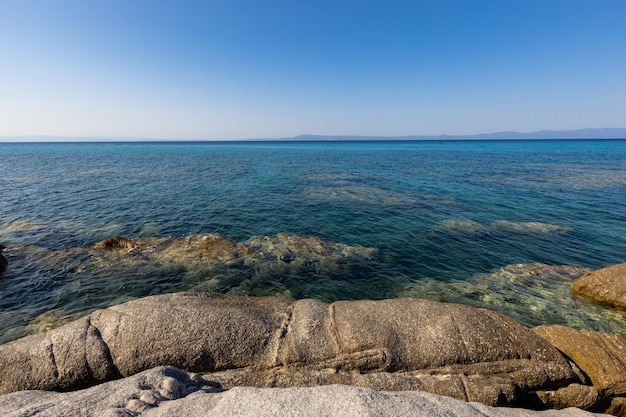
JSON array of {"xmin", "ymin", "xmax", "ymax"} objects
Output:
[{"xmin": 0, "ymin": 293, "xmax": 582, "ymax": 405}]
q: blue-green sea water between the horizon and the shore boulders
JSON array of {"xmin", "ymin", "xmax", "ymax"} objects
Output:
[{"xmin": 0, "ymin": 140, "xmax": 626, "ymax": 342}]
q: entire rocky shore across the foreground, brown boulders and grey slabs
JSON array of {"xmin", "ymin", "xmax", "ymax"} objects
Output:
[{"xmin": 0, "ymin": 293, "xmax": 626, "ymax": 416}]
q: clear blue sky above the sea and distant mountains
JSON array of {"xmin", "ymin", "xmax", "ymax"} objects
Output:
[{"xmin": 0, "ymin": 0, "xmax": 626, "ymax": 139}]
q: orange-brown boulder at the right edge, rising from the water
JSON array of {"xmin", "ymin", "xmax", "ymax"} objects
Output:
[{"xmin": 572, "ymin": 263, "xmax": 626, "ymax": 308}]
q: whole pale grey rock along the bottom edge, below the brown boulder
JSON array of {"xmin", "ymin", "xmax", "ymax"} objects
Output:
[{"xmin": 0, "ymin": 367, "xmax": 592, "ymax": 417}]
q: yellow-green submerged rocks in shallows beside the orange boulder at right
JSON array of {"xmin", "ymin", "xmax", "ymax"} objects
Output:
[{"xmin": 398, "ymin": 264, "xmax": 626, "ymax": 336}]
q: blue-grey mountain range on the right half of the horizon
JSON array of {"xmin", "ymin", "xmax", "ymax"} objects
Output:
[{"xmin": 279, "ymin": 128, "xmax": 626, "ymax": 141}]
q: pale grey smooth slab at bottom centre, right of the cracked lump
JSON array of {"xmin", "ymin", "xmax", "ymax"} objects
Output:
[{"xmin": 151, "ymin": 385, "xmax": 592, "ymax": 417}]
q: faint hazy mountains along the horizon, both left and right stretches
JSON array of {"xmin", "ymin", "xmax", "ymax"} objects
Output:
[{"xmin": 0, "ymin": 128, "xmax": 626, "ymax": 142}]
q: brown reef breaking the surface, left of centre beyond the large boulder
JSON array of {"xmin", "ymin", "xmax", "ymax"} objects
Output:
[{"xmin": 84, "ymin": 233, "xmax": 377, "ymax": 281}]
